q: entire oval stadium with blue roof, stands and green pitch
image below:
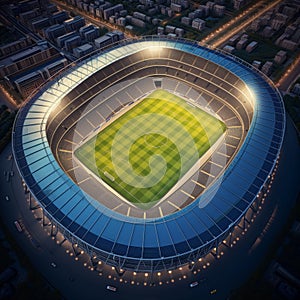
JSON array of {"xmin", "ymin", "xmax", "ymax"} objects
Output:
[{"xmin": 13, "ymin": 36, "xmax": 285, "ymax": 272}]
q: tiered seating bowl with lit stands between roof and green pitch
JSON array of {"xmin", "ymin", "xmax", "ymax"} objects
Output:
[{"xmin": 47, "ymin": 47, "xmax": 254, "ymax": 218}]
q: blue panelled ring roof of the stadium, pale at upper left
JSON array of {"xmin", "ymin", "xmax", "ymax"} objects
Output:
[{"xmin": 13, "ymin": 37, "xmax": 285, "ymax": 260}]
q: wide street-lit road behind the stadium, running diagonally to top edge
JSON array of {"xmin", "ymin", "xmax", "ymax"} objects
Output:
[{"xmin": 202, "ymin": 0, "xmax": 281, "ymax": 48}]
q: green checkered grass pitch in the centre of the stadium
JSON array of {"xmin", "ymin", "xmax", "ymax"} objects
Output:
[{"xmin": 75, "ymin": 90, "xmax": 226, "ymax": 209}]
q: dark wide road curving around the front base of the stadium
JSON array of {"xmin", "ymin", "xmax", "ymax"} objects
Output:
[{"xmin": 0, "ymin": 113, "xmax": 300, "ymax": 300}]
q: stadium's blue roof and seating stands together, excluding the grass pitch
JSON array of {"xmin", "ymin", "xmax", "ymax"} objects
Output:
[{"xmin": 13, "ymin": 36, "xmax": 285, "ymax": 272}]
